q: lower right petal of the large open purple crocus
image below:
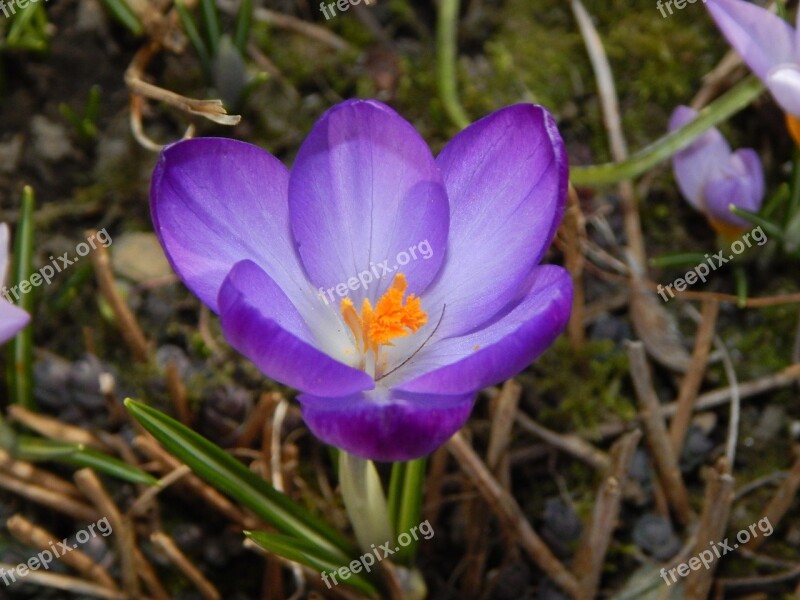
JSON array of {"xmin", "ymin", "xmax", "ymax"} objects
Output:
[{"xmin": 386, "ymin": 265, "xmax": 572, "ymax": 394}]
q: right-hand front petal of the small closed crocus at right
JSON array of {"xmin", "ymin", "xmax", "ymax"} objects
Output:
[{"xmin": 705, "ymin": 148, "xmax": 764, "ymax": 227}]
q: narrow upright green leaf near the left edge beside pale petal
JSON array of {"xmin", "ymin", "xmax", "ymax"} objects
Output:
[{"xmin": 8, "ymin": 185, "xmax": 36, "ymax": 410}]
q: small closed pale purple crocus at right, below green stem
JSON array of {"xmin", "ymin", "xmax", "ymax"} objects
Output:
[{"xmin": 669, "ymin": 106, "xmax": 764, "ymax": 237}]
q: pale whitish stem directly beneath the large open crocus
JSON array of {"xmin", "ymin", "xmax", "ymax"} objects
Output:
[{"xmin": 339, "ymin": 450, "xmax": 394, "ymax": 552}]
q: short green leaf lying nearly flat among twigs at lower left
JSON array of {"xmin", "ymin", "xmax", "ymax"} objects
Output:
[{"xmin": 12, "ymin": 436, "xmax": 158, "ymax": 485}]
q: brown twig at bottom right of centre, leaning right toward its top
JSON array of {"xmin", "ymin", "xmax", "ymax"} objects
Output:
[{"xmin": 572, "ymin": 429, "xmax": 642, "ymax": 600}]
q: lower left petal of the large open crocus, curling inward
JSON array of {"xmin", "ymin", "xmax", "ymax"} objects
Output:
[{"xmin": 218, "ymin": 260, "xmax": 374, "ymax": 396}]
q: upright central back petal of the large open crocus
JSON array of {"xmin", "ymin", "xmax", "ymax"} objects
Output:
[{"xmin": 289, "ymin": 100, "xmax": 449, "ymax": 306}]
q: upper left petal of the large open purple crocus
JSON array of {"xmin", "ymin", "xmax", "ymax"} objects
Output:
[{"xmin": 150, "ymin": 138, "xmax": 319, "ymax": 312}]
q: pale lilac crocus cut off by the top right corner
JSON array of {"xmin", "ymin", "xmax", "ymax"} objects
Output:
[{"xmin": 705, "ymin": 0, "xmax": 800, "ymax": 144}]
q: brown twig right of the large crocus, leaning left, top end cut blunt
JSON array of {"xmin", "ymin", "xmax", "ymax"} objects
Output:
[{"xmin": 628, "ymin": 342, "xmax": 694, "ymax": 526}]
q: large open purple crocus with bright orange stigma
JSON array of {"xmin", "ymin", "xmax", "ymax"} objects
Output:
[{"xmin": 151, "ymin": 100, "xmax": 572, "ymax": 461}]
